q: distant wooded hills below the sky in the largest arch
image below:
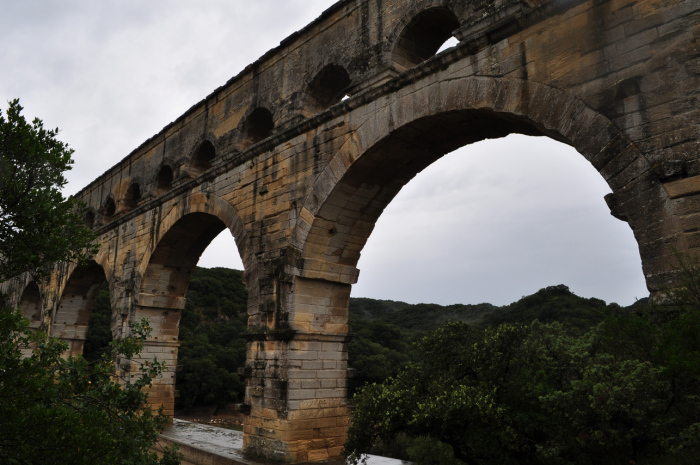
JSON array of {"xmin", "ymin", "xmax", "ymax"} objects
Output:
[{"xmin": 348, "ymin": 285, "xmax": 628, "ymax": 396}]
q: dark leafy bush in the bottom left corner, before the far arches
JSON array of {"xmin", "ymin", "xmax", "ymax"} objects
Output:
[{"xmin": 0, "ymin": 309, "xmax": 179, "ymax": 465}]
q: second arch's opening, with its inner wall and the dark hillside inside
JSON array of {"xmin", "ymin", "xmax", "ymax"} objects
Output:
[{"xmin": 135, "ymin": 212, "xmax": 248, "ymax": 415}]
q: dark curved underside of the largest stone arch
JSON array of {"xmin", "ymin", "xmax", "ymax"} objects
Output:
[{"xmin": 304, "ymin": 110, "xmax": 561, "ymax": 266}]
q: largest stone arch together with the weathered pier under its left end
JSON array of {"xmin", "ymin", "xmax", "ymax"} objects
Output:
[{"xmin": 244, "ymin": 73, "xmax": 679, "ymax": 460}]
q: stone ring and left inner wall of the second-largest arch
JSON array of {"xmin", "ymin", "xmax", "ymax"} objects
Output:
[{"xmin": 126, "ymin": 192, "xmax": 256, "ymax": 415}]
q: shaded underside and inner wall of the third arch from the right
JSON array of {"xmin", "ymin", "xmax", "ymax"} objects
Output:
[{"xmin": 51, "ymin": 261, "xmax": 107, "ymax": 355}]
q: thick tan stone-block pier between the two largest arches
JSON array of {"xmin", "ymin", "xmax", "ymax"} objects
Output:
[{"xmin": 243, "ymin": 254, "xmax": 357, "ymax": 463}]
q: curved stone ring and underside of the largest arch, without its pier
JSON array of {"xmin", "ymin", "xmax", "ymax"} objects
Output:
[{"xmin": 293, "ymin": 77, "xmax": 671, "ymax": 292}]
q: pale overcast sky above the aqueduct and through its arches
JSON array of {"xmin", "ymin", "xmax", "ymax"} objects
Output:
[{"xmin": 0, "ymin": 0, "xmax": 648, "ymax": 305}]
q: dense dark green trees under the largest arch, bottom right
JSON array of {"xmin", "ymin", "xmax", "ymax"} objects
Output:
[{"xmin": 346, "ymin": 315, "xmax": 700, "ymax": 465}]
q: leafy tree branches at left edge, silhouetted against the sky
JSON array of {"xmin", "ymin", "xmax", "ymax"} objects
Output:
[{"xmin": 0, "ymin": 100, "xmax": 95, "ymax": 282}]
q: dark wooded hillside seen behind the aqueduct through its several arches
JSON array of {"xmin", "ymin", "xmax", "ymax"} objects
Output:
[{"xmin": 84, "ymin": 268, "xmax": 640, "ymax": 410}]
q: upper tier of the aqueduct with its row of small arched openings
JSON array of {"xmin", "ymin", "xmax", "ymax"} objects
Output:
[{"xmin": 74, "ymin": 0, "xmax": 504, "ymax": 227}]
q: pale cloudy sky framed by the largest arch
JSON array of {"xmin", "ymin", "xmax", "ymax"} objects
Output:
[{"xmin": 352, "ymin": 134, "xmax": 648, "ymax": 306}]
